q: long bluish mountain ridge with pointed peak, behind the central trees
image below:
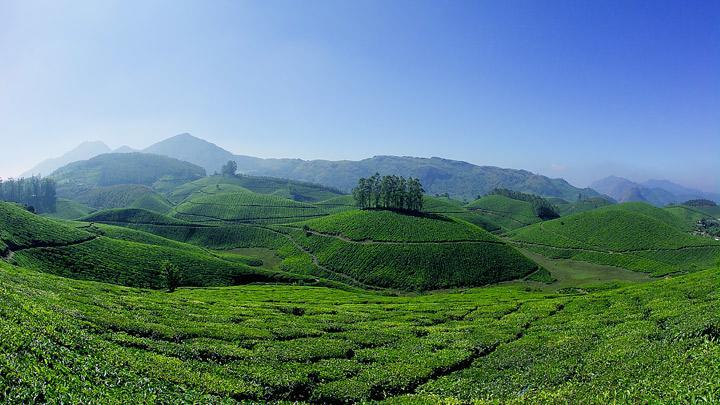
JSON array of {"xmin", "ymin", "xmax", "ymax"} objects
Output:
[{"xmin": 143, "ymin": 134, "xmax": 599, "ymax": 201}]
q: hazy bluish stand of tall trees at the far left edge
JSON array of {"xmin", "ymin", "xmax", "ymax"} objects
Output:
[{"xmin": 0, "ymin": 176, "xmax": 57, "ymax": 212}]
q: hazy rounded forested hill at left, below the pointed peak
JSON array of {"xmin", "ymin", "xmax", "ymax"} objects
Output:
[{"xmin": 50, "ymin": 153, "xmax": 205, "ymax": 198}]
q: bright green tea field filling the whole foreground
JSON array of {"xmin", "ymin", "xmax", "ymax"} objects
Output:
[{"xmin": 0, "ymin": 262, "xmax": 720, "ymax": 403}]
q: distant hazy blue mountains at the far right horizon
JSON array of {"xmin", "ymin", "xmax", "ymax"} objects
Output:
[{"xmin": 590, "ymin": 176, "xmax": 720, "ymax": 206}]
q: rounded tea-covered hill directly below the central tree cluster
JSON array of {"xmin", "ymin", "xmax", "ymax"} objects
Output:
[{"xmin": 286, "ymin": 210, "xmax": 538, "ymax": 290}]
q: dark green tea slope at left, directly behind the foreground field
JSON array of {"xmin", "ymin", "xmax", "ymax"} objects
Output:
[{"xmin": 0, "ymin": 203, "xmax": 330, "ymax": 288}]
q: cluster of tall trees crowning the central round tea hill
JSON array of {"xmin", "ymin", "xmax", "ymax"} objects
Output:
[{"xmin": 353, "ymin": 173, "xmax": 425, "ymax": 212}]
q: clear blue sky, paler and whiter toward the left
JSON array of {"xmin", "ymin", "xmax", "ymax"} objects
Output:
[{"xmin": 0, "ymin": 0, "xmax": 720, "ymax": 191}]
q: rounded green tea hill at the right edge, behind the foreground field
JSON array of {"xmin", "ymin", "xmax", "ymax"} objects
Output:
[{"xmin": 510, "ymin": 203, "xmax": 720, "ymax": 275}]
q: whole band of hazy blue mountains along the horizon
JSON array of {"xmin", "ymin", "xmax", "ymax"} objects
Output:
[{"xmin": 19, "ymin": 133, "xmax": 720, "ymax": 206}]
